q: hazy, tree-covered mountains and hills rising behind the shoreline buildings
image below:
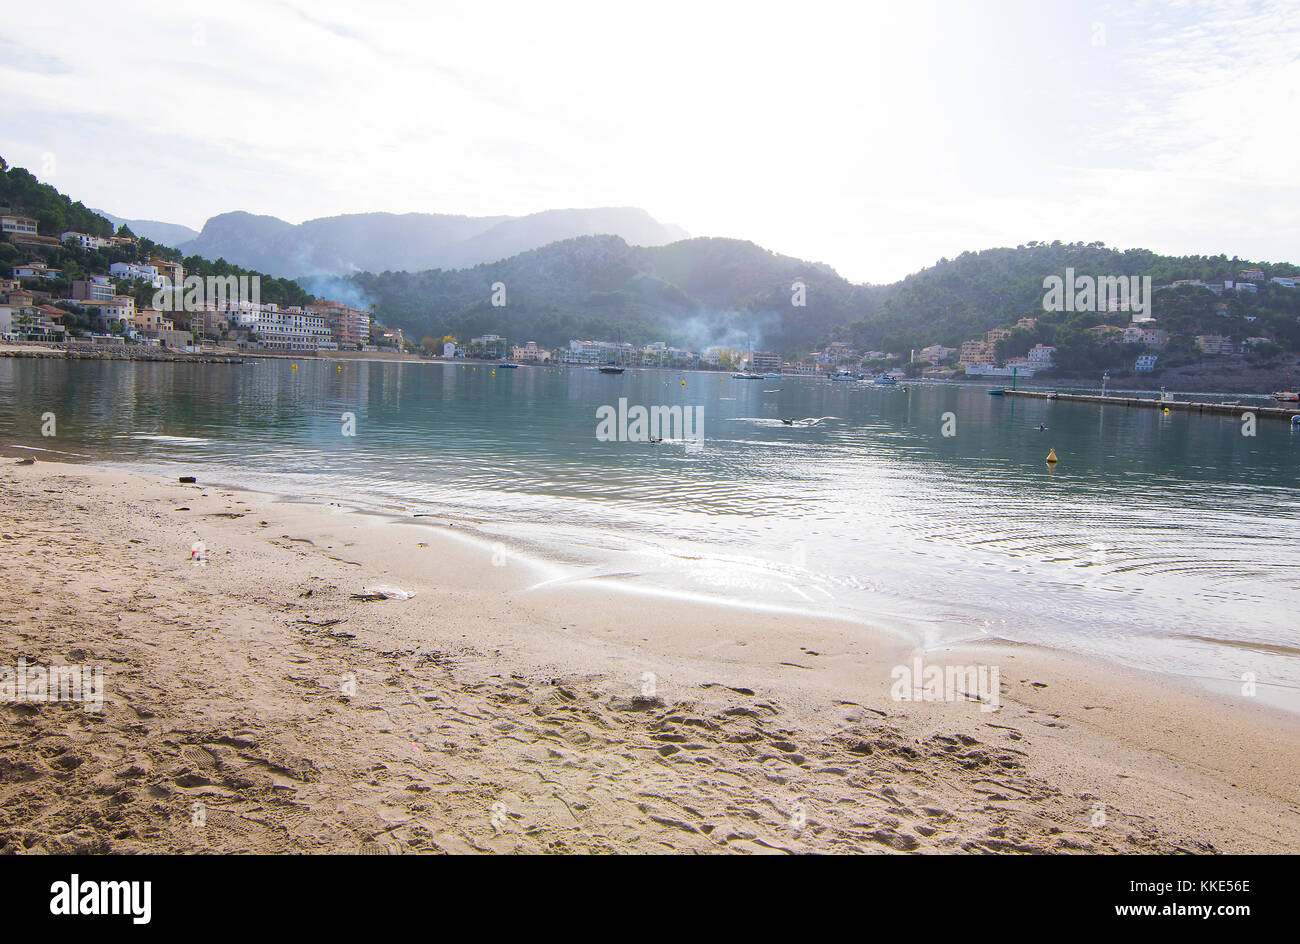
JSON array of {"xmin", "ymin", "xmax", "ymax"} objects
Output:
[{"xmin": 0, "ymin": 157, "xmax": 1300, "ymax": 369}]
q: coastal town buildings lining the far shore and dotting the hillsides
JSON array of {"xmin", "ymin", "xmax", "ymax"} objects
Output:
[{"xmin": 0, "ymin": 207, "xmax": 1300, "ymax": 390}]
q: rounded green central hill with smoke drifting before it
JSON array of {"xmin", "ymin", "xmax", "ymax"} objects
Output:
[{"xmin": 351, "ymin": 235, "xmax": 889, "ymax": 351}]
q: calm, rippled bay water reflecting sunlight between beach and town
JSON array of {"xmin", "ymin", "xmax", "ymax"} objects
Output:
[{"xmin": 0, "ymin": 359, "xmax": 1300, "ymax": 696}]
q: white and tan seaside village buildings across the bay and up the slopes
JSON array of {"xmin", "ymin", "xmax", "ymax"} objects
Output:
[{"xmin": 0, "ymin": 207, "xmax": 1300, "ymax": 380}]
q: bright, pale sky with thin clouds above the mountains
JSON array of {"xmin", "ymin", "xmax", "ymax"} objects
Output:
[{"xmin": 0, "ymin": 0, "xmax": 1300, "ymax": 282}]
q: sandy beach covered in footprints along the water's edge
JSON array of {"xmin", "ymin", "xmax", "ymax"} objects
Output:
[{"xmin": 0, "ymin": 450, "xmax": 1300, "ymax": 854}]
